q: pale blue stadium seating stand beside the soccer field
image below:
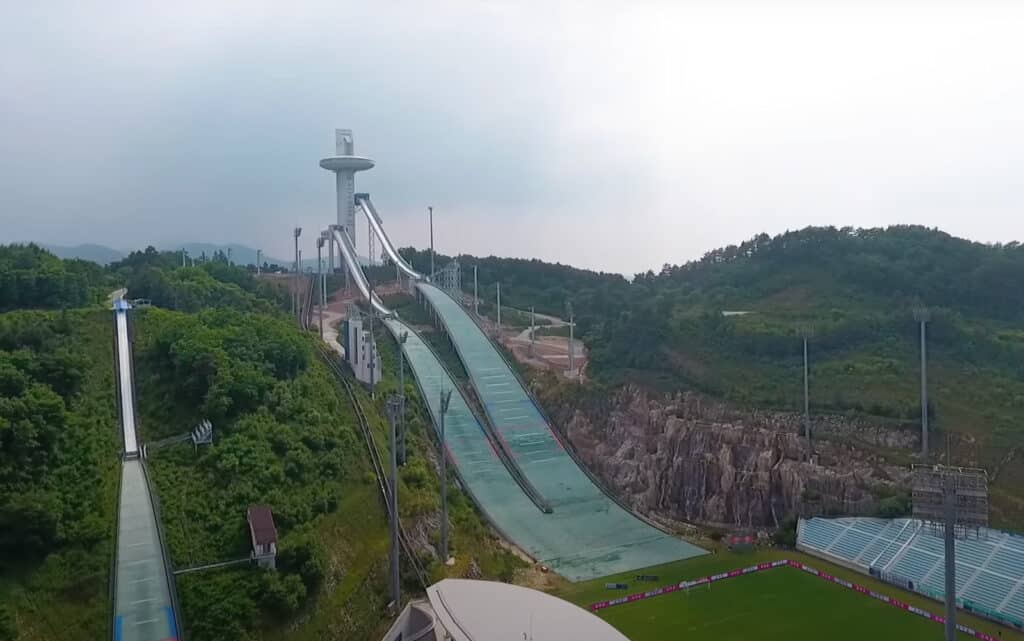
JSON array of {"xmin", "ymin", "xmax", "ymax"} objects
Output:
[{"xmin": 797, "ymin": 517, "xmax": 1024, "ymax": 628}]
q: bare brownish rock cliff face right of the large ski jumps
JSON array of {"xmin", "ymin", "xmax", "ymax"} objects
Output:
[{"xmin": 538, "ymin": 386, "xmax": 916, "ymax": 528}]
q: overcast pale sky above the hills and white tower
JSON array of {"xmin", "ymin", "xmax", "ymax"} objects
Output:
[{"xmin": 0, "ymin": 0, "xmax": 1024, "ymax": 273}]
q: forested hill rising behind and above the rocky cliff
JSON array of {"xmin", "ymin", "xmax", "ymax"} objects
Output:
[{"xmin": 420, "ymin": 226, "xmax": 1024, "ymax": 528}]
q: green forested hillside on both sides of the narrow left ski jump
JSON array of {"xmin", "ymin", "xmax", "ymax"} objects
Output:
[{"xmin": 0, "ymin": 240, "xmax": 520, "ymax": 641}]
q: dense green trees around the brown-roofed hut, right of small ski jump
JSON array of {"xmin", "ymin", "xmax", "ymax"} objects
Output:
[{"xmin": 136, "ymin": 309, "xmax": 352, "ymax": 639}]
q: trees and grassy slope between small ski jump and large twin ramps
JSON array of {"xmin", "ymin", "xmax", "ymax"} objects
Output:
[{"xmin": 135, "ymin": 309, "xmax": 518, "ymax": 641}]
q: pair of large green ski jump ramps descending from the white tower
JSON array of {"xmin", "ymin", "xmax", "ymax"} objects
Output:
[{"xmin": 333, "ymin": 195, "xmax": 706, "ymax": 581}]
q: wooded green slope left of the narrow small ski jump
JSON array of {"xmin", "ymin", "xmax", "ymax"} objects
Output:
[{"xmin": 0, "ymin": 310, "xmax": 118, "ymax": 639}]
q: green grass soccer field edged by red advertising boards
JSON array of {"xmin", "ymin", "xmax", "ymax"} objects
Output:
[{"xmin": 562, "ymin": 551, "xmax": 1024, "ymax": 641}]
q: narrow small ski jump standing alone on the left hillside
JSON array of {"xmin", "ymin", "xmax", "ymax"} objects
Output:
[{"xmin": 113, "ymin": 300, "xmax": 178, "ymax": 641}]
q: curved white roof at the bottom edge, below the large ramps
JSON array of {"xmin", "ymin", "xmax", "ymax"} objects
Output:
[{"xmin": 427, "ymin": 579, "xmax": 629, "ymax": 641}]
